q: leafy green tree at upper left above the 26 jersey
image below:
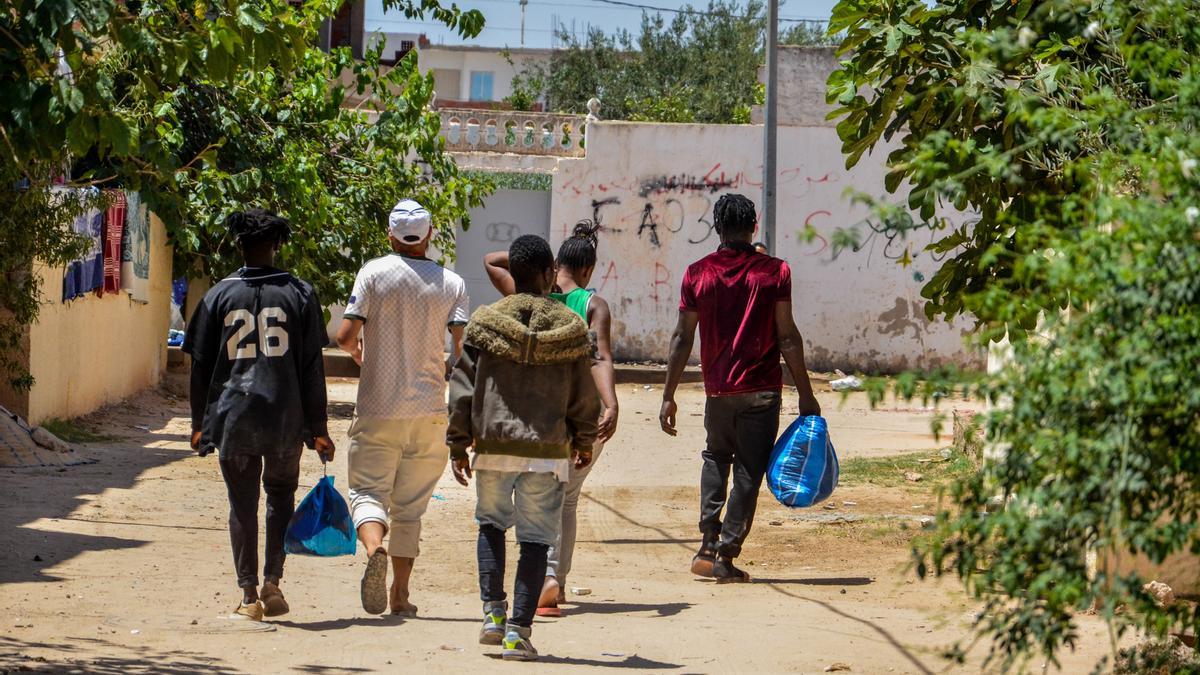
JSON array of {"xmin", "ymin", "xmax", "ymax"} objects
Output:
[{"xmin": 0, "ymin": 0, "xmax": 486, "ymax": 386}]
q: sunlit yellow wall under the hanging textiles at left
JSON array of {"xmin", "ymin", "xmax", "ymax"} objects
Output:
[{"xmin": 28, "ymin": 215, "xmax": 172, "ymax": 424}]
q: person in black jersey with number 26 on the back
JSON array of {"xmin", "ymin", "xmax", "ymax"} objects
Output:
[{"xmin": 184, "ymin": 209, "xmax": 334, "ymax": 621}]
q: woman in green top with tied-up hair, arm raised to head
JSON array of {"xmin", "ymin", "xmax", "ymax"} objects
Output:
[{"xmin": 484, "ymin": 220, "xmax": 617, "ymax": 616}]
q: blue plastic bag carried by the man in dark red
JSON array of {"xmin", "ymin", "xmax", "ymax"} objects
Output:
[{"xmin": 767, "ymin": 414, "xmax": 838, "ymax": 508}]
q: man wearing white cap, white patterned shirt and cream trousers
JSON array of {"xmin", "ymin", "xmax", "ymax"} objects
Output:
[{"xmin": 337, "ymin": 199, "xmax": 470, "ymax": 615}]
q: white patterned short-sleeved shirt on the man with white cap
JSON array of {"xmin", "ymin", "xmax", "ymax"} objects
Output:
[{"xmin": 344, "ymin": 253, "xmax": 470, "ymax": 419}]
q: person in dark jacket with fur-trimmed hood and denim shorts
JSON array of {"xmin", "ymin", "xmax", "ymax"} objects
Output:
[{"xmin": 446, "ymin": 234, "xmax": 600, "ymax": 661}]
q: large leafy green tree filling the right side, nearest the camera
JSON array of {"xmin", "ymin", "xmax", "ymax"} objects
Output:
[{"xmin": 828, "ymin": 0, "xmax": 1200, "ymax": 668}]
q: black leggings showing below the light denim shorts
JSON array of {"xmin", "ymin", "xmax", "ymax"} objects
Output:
[{"xmin": 476, "ymin": 525, "xmax": 550, "ymax": 628}]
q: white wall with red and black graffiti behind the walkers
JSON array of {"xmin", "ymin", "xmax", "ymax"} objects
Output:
[{"xmin": 551, "ymin": 123, "xmax": 983, "ymax": 371}]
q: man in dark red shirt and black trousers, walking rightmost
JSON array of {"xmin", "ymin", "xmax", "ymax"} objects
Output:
[{"xmin": 659, "ymin": 195, "xmax": 821, "ymax": 584}]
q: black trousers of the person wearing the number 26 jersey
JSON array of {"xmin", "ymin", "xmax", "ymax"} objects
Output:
[{"xmin": 221, "ymin": 448, "xmax": 302, "ymax": 589}]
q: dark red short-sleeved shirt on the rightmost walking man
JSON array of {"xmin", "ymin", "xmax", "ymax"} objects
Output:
[{"xmin": 679, "ymin": 247, "xmax": 792, "ymax": 396}]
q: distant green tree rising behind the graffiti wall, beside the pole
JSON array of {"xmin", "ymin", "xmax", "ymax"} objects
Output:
[{"xmin": 518, "ymin": 0, "xmax": 828, "ymax": 124}]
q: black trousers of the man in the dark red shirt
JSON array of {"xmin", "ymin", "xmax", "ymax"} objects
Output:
[{"xmin": 700, "ymin": 392, "xmax": 780, "ymax": 557}]
